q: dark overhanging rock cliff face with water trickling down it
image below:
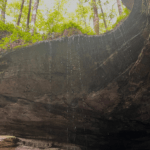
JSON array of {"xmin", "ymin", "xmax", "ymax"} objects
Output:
[{"xmin": 0, "ymin": 0, "xmax": 150, "ymax": 150}]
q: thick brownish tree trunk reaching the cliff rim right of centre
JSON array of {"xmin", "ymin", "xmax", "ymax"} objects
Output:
[{"xmin": 93, "ymin": 0, "xmax": 99, "ymax": 35}]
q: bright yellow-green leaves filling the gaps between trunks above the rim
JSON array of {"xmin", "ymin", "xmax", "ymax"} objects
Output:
[{"xmin": 0, "ymin": 0, "xmax": 130, "ymax": 49}]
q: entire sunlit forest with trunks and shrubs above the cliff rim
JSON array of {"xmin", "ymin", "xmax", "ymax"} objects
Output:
[{"xmin": 0, "ymin": 0, "xmax": 130, "ymax": 51}]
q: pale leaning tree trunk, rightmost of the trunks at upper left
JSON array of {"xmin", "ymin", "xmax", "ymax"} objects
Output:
[{"xmin": 30, "ymin": 0, "xmax": 39, "ymax": 34}]
